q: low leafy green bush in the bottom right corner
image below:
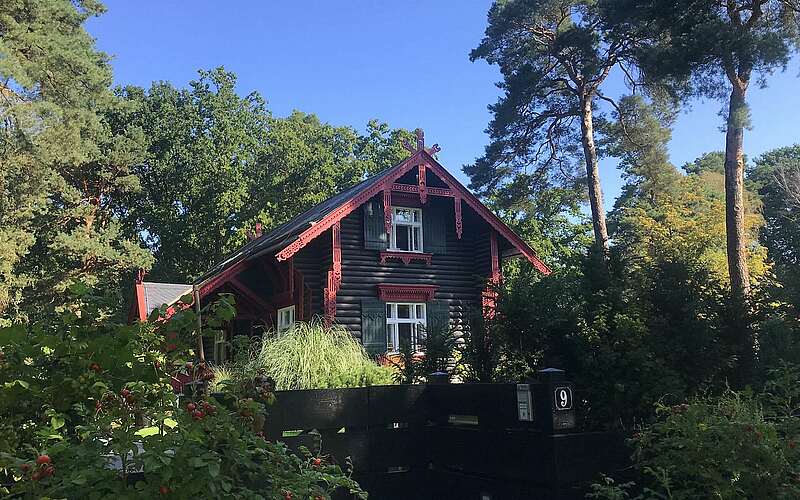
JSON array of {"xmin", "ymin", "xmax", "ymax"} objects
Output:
[{"xmin": 593, "ymin": 366, "xmax": 800, "ymax": 499}]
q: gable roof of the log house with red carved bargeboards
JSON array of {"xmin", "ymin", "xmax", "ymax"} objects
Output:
[{"xmin": 195, "ymin": 149, "xmax": 550, "ymax": 288}]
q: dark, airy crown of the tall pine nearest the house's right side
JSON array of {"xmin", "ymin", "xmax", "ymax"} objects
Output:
[{"xmin": 464, "ymin": 0, "xmax": 625, "ymax": 250}]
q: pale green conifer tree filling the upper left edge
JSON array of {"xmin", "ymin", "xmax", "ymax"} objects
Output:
[{"xmin": 0, "ymin": 0, "xmax": 152, "ymax": 319}]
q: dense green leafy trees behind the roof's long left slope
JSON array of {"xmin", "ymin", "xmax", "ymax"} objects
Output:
[{"xmin": 120, "ymin": 68, "xmax": 409, "ymax": 281}]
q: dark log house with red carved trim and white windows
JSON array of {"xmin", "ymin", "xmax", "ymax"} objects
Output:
[{"xmin": 131, "ymin": 130, "xmax": 550, "ymax": 360}]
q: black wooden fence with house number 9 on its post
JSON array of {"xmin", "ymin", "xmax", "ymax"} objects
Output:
[{"xmin": 265, "ymin": 381, "xmax": 628, "ymax": 500}]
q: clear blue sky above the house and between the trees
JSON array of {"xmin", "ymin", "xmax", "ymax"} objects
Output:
[{"xmin": 88, "ymin": 0, "xmax": 800, "ymax": 211}]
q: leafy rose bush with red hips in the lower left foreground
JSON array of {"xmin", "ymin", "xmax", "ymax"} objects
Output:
[{"xmin": 0, "ymin": 289, "xmax": 366, "ymax": 499}]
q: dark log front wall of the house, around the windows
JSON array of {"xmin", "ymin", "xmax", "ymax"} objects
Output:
[{"xmin": 334, "ymin": 193, "xmax": 490, "ymax": 338}]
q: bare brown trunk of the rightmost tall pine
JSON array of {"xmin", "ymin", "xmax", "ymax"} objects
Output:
[{"xmin": 725, "ymin": 82, "xmax": 750, "ymax": 303}]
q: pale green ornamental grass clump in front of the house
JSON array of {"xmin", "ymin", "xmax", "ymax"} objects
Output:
[{"xmin": 250, "ymin": 321, "xmax": 393, "ymax": 390}]
